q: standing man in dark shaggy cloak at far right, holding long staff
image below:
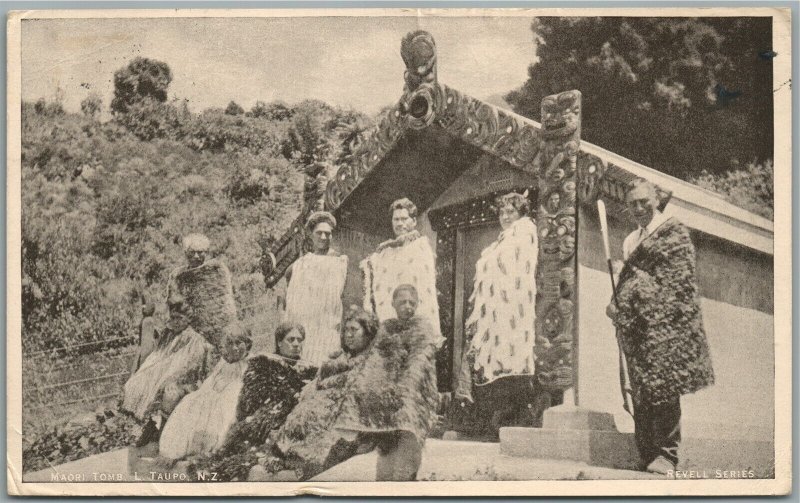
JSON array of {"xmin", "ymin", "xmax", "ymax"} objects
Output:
[{"xmin": 606, "ymin": 179, "xmax": 714, "ymax": 474}]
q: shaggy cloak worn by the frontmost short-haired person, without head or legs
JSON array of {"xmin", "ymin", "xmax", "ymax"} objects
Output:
[{"xmin": 336, "ymin": 317, "xmax": 439, "ymax": 442}]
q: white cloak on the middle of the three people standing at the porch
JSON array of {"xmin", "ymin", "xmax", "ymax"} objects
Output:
[{"xmin": 361, "ymin": 231, "xmax": 441, "ymax": 338}]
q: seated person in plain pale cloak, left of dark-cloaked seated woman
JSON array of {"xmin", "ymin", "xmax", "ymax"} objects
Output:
[{"xmin": 159, "ymin": 323, "xmax": 253, "ymax": 459}]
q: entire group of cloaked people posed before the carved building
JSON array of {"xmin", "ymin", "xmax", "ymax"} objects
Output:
[{"xmin": 123, "ymin": 180, "xmax": 714, "ymax": 481}]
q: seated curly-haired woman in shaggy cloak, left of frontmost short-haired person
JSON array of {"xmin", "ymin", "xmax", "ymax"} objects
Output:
[{"xmin": 260, "ymin": 306, "xmax": 378, "ymax": 480}]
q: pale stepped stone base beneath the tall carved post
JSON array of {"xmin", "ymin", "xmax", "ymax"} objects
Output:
[{"xmin": 500, "ymin": 404, "xmax": 639, "ymax": 470}]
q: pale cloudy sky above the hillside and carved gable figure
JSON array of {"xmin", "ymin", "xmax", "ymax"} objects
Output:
[{"xmin": 22, "ymin": 16, "xmax": 536, "ymax": 114}]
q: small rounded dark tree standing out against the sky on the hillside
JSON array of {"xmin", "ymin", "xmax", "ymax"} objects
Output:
[{"xmin": 111, "ymin": 57, "xmax": 172, "ymax": 113}]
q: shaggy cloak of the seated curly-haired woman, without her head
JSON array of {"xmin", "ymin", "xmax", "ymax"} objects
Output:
[{"xmin": 270, "ymin": 351, "xmax": 367, "ymax": 480}]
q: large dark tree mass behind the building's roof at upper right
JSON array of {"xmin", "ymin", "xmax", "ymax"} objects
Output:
[{"xmin": 506, "ymin": 17, "xmax": 773, "ymax": 179}]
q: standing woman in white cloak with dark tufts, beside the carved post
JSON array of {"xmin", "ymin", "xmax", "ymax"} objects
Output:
[{"xmin": 456, "ymin": 192, "xmax": 539, "ymax": 430}]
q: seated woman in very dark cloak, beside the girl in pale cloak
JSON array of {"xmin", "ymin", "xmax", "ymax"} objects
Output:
[{"xmin": 187, "ymin": 323, "xmax": 317, "ymax": 481}]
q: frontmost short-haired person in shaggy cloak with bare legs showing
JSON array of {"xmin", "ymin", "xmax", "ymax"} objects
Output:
[{"xmin": 335, "ymin": 285, "xmax": 439, "ymax": 481}]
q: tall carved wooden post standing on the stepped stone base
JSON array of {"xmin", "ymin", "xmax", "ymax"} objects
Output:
[{"xmin": 535, "ymin": 91, "xmax": 581, "ymax": 405}]
